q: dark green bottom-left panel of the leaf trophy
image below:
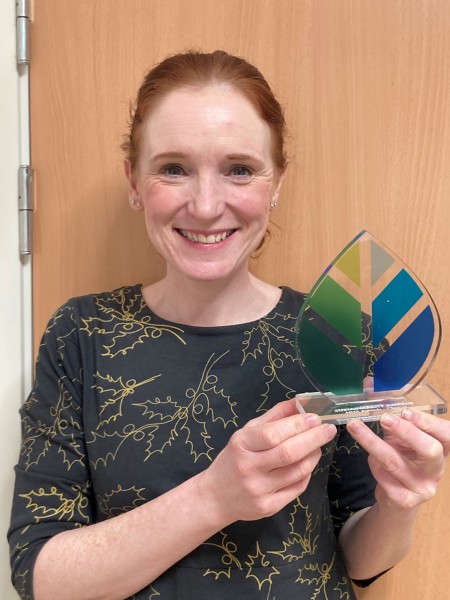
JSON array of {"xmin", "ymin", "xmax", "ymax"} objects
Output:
[{"xmin": 297, "ymin": 319, "xmax": 364, "ymax": 395}]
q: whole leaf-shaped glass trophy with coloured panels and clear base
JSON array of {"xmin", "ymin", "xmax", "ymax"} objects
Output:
[{"xmin": 296, "ymin": 231, "xmax": 447, "ymax": 423}]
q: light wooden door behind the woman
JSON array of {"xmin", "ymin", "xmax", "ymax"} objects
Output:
[{"xmin": 31, "ymin": 0, "xmax": 450, "ymax": 600}]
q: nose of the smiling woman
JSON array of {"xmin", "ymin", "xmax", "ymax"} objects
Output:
[{"xmin": 188, "ymin": 173, "xmax": 225, "ymax": 221}]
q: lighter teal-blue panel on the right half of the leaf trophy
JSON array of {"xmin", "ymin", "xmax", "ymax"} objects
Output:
[{"xmin": 372, "ymin": 269, "xmax": 422, "ymax": 347}]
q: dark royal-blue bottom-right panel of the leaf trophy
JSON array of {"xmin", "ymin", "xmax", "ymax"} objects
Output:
[{"xmin": 373, "ymin": 306, "xmax": 434, "ymax": 392}]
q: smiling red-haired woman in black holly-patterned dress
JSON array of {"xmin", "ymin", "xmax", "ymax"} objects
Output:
[{"xmin": 10, "ymin": 51, "xmax": 450, "ymax": 600}]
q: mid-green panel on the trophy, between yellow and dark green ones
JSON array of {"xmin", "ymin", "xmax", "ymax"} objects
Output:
[{"xmin": 309, "ymin": 275, "xmax": 362, "ymax": 348}]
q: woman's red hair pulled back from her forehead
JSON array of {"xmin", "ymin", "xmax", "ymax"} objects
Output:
[{"xmin": 122, "ymin": 50, "xmax": 286, "ymax": 172}]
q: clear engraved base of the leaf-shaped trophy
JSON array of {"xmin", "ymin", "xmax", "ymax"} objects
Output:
[{"xmin": 296, "ymin": 383, "xmax": 447, "ymax": 425}]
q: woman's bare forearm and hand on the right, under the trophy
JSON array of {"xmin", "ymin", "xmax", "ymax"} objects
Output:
[{"xmin": 339, "ymin": 411, "xmax": 450, "ymax": 580}]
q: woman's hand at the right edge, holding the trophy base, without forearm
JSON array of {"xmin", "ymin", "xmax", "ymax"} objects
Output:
[{"xmin": 347, "ymin": 409, "xmax": 450, "ymax": 509}]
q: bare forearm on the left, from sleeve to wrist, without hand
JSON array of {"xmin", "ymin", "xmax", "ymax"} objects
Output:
[{"xmin": 33, "ymin": 468, "xmax": 224, "ymax": 600}]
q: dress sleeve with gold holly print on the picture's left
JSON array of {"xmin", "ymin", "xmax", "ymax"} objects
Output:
[{"xmin": 8, "ymin": 304, "xmax": 94, "ymax": 600}]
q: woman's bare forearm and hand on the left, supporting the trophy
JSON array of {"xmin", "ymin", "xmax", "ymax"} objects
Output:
[{"xmin": 20, "ymin": 401, "xmax": 336, "ymax": 600}]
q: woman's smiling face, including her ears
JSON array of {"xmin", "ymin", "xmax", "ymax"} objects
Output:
[{"xmin": 126, "ymin": 85, "xmax": 282, "ymax": 281}]
